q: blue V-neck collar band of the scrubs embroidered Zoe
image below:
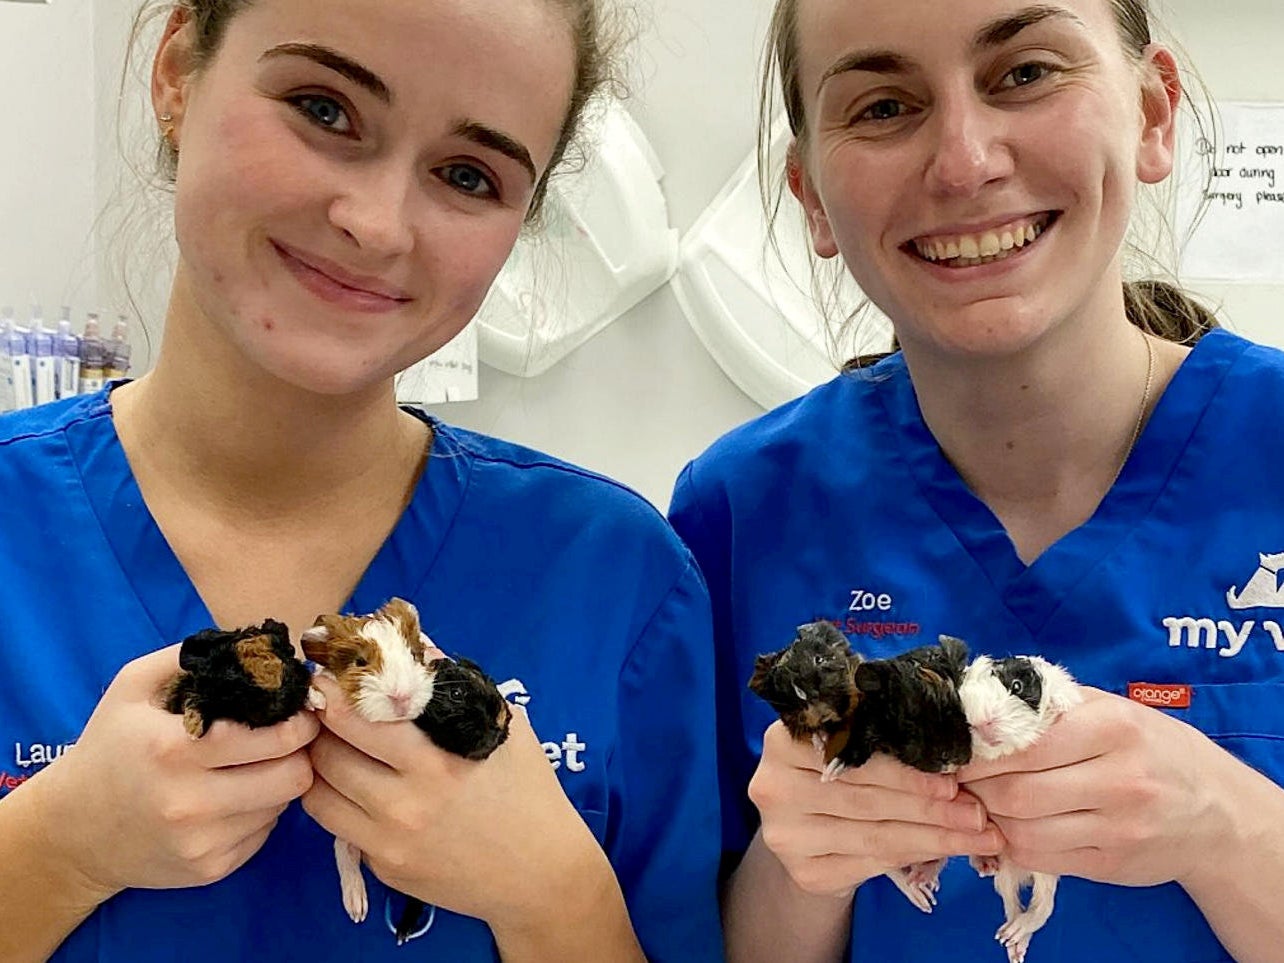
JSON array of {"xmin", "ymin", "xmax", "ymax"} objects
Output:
[{"xmin": 876, "ymin": 330, "xmax": 1251, "ymax": 634}]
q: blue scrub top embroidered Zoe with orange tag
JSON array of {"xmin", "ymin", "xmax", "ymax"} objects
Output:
[{"xmin": 670, "ymin": 330, "xmax": 1284, "ymax": 963}]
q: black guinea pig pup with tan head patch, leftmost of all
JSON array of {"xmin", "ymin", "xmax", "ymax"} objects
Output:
[{"xmin": 163, "ymin": 619, "xmax": 312, "ymax": 738}]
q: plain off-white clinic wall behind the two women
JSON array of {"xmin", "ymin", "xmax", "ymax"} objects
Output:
[{"xmin": 0, "ymin": 0, "xmax": 1284, "ymax": 507}]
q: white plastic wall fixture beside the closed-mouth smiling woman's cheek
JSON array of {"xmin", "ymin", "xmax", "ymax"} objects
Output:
[{"xmin": 476, "ymin": 98, "xmax": 678, "ymax": 377}]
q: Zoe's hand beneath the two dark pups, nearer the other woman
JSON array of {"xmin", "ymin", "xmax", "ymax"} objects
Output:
[{"xmin": 749, "ymin": 722, "xmax": 1003, "ymax": 898}]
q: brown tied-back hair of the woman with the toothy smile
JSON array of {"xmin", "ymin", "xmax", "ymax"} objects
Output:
[{"xmin": 758, "ymin": 0, "xmax": 1219, "ymax": 369}]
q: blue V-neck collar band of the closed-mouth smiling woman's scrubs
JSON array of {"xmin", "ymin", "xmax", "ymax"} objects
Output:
[{"xmin": 67, "ymin": 400, "xmax": 473, "ymax": 645}]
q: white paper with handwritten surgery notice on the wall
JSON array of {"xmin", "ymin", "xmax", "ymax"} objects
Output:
[{"xmin": 1177, "ymin": 103, "xmax": 1284, "ymax": 284}]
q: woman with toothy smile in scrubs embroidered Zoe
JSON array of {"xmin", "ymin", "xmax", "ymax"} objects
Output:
[{"xmin": 670, "ymin": 0, "xmax": 1284, "ymax": 963}]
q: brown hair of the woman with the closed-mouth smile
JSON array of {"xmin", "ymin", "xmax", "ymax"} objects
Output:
[{"xmin": 131, "ymin": 0, "xmax": 627, "ymax": 223}]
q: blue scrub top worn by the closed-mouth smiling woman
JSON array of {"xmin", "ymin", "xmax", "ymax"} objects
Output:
[{"xmin": 0, "ymin": 390, "xmax": 722, "ymax": 963}]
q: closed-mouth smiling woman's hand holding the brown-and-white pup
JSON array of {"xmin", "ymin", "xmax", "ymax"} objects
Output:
[{"xmin": 303, "ymin": 677, "xmax": 614, "ymax": 930}]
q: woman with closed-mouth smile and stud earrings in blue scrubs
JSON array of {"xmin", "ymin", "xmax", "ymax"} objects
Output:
[{"xmin": 0, "ymin": 0, "xmax": 722, "ymax": 963}]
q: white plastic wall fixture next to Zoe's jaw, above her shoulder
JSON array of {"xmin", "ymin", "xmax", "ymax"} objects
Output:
[{"xmin": 673, "ymin": 118, "xmax": 891, "ymax": 408}]
